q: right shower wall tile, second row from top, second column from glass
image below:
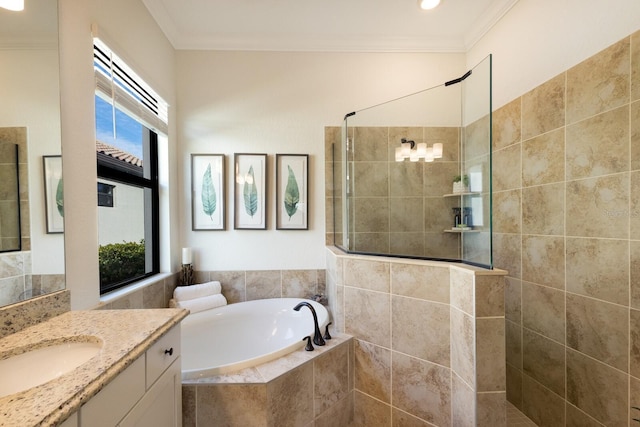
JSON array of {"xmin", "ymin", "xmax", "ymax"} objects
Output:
[{"xmin": 522, "ymin": 128, "xmax": 565, "ymax": 187}]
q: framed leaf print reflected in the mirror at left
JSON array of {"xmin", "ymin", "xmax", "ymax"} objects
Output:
[{"xmin": 42, "ymin": 155, "xmax": 64, "ymax": 234}]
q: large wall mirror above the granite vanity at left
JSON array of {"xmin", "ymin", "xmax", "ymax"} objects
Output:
[{"xmin": 0, "ymin": 0, "xmax": 65, "ymax": 306}]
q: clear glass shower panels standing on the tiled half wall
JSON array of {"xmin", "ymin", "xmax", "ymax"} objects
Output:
[{"xmin": 333, "ymin": 56, "xmax": 493, "ymax": 268}]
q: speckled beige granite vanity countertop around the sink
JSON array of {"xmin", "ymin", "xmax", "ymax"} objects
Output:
[{"xmin": 0, "ymin": 309, "xmax": 188, "ymax": 427}]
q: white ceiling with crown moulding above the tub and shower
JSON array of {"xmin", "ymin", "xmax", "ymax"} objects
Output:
[{"xmin": 142, "ymin": 0, "xmax": 518, "ymax": 52}]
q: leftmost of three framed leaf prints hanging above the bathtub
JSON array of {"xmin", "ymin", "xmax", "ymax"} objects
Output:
[{"xmin": 191, "ymin": 154, "xmax": 226, "ymax": 231}]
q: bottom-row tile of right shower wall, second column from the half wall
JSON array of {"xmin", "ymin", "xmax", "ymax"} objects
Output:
[{"xmin": 522, "ymin": 375, "xmax": 565, "ymax": 427}]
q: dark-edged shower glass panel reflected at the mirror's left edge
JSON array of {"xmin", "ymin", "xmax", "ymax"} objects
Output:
[{"xmin": 0, "ymin": 142, "xmax": 20, "ymax": 252}]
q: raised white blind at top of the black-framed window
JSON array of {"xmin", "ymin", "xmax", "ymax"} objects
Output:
[{"xmin": 93, "ymin": 38, "xmax": 168, "ymax": 135}]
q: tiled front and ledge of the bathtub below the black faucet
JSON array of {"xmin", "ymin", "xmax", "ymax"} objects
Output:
[{"xmin": 182, "ymin": 333, "xmax": 354, "ymax": 427}]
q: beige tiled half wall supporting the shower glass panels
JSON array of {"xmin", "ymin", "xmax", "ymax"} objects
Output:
[{"xmin": 327, "ymin": 247, "xmax": 506, "ymax": 427}]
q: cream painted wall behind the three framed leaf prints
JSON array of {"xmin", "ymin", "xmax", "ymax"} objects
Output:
[{"xmin": 177, "ymin": 51, "xmax": 464, "ymax": 270}]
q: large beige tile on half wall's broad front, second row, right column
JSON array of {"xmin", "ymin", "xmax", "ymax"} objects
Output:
[{"xmin": 391, "ymin": 296, "xmax": 450, "ymax": 366}]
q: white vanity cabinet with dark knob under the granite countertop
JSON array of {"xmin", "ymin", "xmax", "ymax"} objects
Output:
[{"xmin": 78, "ymin": 326, "xmax": 182, "ymax": 427}]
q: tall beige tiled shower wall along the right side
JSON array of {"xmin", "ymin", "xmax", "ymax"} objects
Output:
[{"xmin": 493, "ymin": 33, "xmax": 640, "ymax": 426}]
